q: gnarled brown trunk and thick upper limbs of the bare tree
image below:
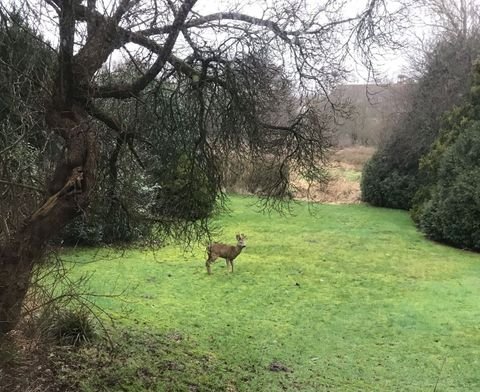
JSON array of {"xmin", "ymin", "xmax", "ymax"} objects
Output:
[{"xmin": 0, "ymin": 0, "xmax": 196, "ymax": 336}]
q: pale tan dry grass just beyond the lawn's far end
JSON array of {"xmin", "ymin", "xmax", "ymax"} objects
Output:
[{"xmin": 293, "ymin": 146, "xmax": 375, "ymax": 204}]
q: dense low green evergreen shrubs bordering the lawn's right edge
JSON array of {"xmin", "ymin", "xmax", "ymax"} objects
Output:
[{"xmin": 362, "ymin": 61, "xmax": 480, "ymax": 251}]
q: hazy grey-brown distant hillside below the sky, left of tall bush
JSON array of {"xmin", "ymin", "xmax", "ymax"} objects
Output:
[{"xmin": 332, "ymin": 82, "xmax": 414, "ymax": 146}]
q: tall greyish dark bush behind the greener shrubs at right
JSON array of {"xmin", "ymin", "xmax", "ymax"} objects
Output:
[{"xmin": 362, "ymin": 34, "xmax": 480, "ymax": 210}]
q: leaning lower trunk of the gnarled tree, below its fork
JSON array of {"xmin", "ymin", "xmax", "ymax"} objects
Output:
[{"xmin": 0, "ymin": 106, "xmax": 97, "ymax": 336}]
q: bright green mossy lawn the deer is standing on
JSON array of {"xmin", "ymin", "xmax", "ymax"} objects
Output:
[{"xmin": 61, "ymin": 197, "xmax": 480, "ymax": 392}]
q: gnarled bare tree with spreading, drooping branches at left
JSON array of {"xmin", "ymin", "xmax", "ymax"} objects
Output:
[{"xmin": 0, "ymin": 0, "xmax": 412, "ymax": 333}]
